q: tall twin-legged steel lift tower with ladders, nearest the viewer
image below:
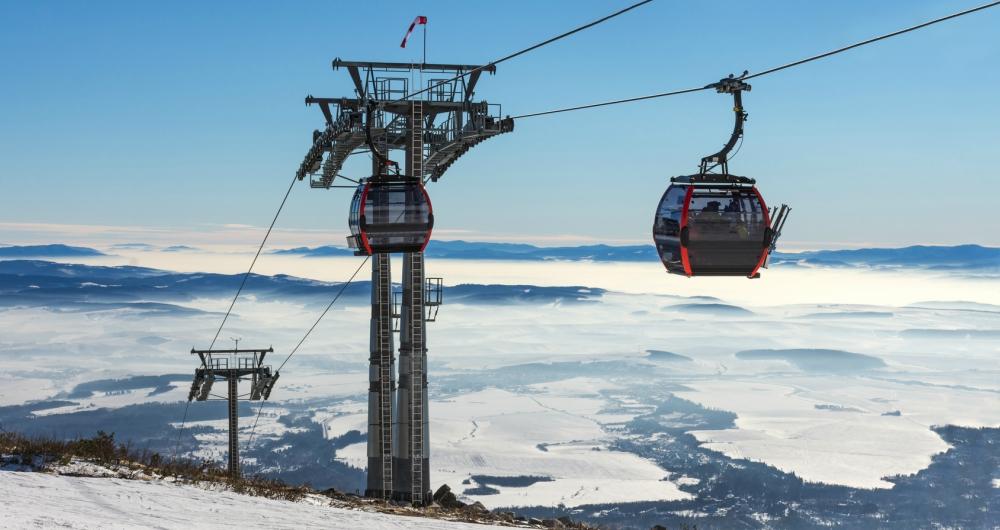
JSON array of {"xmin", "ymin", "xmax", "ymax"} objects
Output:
[{"xmin": 297, "ymin": 59, "xmax": 514, "ymax": 505}]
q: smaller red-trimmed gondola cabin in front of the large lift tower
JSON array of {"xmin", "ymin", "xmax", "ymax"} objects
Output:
[{"xmin": 347, "ymin": 179, "xmax": 434, "ymax": 256}]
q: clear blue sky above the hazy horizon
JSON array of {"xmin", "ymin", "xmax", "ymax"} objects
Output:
[{"xmin": 0, "ymin": 0, "xmax": 1000, "ymax": 246}]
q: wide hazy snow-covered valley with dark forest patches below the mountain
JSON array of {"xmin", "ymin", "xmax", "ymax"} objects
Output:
[{"xmin": 0, "ymin": 254, "xmax": 1000, "ymax": 528}]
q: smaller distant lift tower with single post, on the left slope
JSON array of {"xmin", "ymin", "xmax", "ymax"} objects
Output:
[{"xmin": 188, "ymin": 348, "xmax": 278, "ymax": 478}]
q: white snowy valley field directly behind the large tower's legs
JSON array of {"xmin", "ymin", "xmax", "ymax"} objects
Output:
[{"xmin": 326, "ymin": 386, "xmax": 690, "ymax": 508}]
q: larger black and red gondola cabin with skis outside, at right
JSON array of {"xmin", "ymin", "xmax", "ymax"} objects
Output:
[{"xmin": 653, "ymin": 177, "xmax": 771, "ymax": 278}]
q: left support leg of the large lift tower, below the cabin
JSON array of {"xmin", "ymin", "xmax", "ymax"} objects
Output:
[{"xmin": 365, "ymin": 254, "xmax": 396, "ymax": 499}]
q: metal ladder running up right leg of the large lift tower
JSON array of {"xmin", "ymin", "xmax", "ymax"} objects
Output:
[{"xmin": 407, "ymin": 101, "xmax": 425, "ymax": 506}]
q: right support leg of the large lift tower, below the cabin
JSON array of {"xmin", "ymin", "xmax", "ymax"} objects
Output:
[{"xmin": 393, "ymin": 252, "xmax": 431, "ymax": 506}]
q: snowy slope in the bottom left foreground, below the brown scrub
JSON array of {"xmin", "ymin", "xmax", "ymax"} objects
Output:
[{"xmin": 0, "ymin": 471, "xmax": 496, "ymax": 530}]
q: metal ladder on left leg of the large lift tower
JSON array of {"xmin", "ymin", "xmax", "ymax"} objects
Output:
[{"xmin": 378, "ymin": 256, "xmax": 392, "ymax": 498}]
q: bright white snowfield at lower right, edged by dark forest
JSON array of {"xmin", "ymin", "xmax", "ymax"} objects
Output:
[{"xmin": 678, "ymin": 381, "xmax": 948, "ymax": 488}]
